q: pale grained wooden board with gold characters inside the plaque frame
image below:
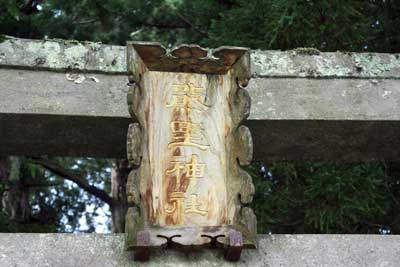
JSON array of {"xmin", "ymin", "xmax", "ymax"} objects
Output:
[{"xmin": 137, "ymin": 72, "xmax": 230, "ymax": 226}]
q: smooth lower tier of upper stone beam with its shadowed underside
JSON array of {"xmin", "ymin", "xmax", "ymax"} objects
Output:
[{"xmin": 0, "ymin": 69, "xmax": 400, "ymax": 160}]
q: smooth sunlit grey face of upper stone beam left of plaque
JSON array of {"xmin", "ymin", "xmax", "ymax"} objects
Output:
[{"xmin": 0, "ymin": 69, "xmax": 129, "ymax": 118}]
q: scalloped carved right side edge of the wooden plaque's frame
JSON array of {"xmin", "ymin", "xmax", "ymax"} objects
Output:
[{"xmin": 228, "ymin": 52, "xmax": 257, "ymax": 248}]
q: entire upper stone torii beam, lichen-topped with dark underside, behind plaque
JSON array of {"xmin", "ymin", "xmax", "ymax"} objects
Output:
[{"xmin": 0, "ymin": 37, "xmax": 400, "ymax": 161}]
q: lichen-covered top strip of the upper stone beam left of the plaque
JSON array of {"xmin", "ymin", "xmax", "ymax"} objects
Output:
[{"xmin": 0, "ymin": 37, "xmax": 126, "ymax": 74}]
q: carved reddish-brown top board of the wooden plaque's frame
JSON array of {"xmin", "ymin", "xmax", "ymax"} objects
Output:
[{"xmin": 127, "ymin": 42, "xmax": 250, "ymax": 75}]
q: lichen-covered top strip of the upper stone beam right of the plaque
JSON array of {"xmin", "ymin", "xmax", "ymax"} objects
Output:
[{"xmin": 251, "ymin": 48, "xmax": 400, "ymax": 78}]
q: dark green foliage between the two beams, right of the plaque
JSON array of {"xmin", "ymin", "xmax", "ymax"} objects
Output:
[{"xmin": 251, "ymin": 162, "xmax": 400, "ymax": 234}]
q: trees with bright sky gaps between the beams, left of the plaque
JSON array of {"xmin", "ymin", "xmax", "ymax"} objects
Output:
[{"xmin": 0, "ymin": 157, "xmax": 112, "ymax": 232}]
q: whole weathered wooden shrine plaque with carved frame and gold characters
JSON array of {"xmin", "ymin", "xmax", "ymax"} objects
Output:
[{"xmin": 126, "ymin": 42, "xmax": 256, "ymax": 260}]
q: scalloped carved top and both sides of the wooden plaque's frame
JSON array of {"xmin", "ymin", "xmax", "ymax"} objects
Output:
[{"xmin": 126, "ymin": 42, "xmax": 257, "ymax": 255}]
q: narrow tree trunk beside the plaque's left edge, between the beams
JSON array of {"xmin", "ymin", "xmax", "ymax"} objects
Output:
[{"xmin": 111, "ymin": 159, "xmax": 131, "ymax": 233}]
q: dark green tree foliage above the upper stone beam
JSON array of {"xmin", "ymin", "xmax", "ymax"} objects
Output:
[{"xmin": 0, "ymin": 0, "xmax": 400, "ymax": 52}]
